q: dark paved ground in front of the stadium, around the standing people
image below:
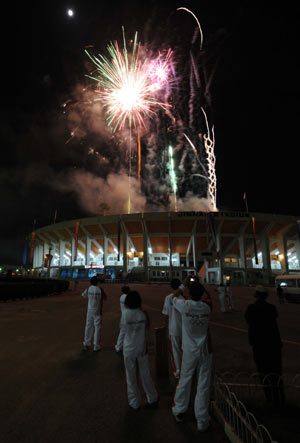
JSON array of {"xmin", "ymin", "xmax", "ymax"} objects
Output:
[{"xmin": 0, "ymin": 282, "xmax": 300, "ymax": 443}]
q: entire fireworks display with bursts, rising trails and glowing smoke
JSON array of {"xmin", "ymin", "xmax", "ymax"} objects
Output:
[{"xmin": 61, "ymin": 8, "xmax": 217, "ymax": 213}]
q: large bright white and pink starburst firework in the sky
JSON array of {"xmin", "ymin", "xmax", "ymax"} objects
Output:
[{"xmin": 85, "ymin": 30, "xmax": 172, "ymax": 131}]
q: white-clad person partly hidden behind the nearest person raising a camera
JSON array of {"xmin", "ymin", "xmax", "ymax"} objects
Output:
[{"xmin": 162, "ymin": 278, "xmax": 185, "ymax": 378}]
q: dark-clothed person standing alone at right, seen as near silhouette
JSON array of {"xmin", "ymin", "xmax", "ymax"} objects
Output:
[{"xmin": 245, "ymin": 286, "xmax": 284, "ymax": 406}]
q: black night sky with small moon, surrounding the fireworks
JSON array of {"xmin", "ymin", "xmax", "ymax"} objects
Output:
[{"xmin": 0, "ymin": 0, "xmax": 300, "ymax": 264}]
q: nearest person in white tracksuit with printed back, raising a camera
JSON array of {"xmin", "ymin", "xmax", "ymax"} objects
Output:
[{"xmin": 172, "ymin": 282, "xmax": 212, "ymax": 431}]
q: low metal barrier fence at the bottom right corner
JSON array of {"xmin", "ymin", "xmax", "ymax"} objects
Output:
[{"xmin": 212, "ymin": 372, "xmax": 300, "ymax": 443}]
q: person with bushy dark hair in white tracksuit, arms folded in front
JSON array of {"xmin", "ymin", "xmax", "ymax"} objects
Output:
[{"xmin": 123, "ymin": 291, "xmax": 159, "ymax": 409}]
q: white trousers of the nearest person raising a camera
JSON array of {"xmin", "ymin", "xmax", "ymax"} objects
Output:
[{"xmin": 172, "ymin": 351, "xmax": 212, "ymax": 428}]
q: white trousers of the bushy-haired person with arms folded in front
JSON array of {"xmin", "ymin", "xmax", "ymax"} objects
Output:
[{"xmin": 124, "ymin": 354, "xmax": 158, "ymax": 409}]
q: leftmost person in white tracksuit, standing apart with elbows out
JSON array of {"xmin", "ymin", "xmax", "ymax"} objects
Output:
[{"xmin": 81, "ymin": 276, "xmax": 104, "ymax": 352}]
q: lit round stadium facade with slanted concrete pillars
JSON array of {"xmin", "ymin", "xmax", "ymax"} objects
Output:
[{"xmin": 33, "ymin": 211, "xmax": 300, "ymax": 285}]
